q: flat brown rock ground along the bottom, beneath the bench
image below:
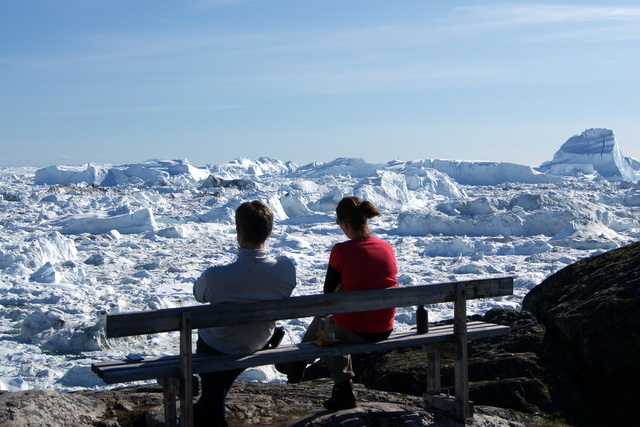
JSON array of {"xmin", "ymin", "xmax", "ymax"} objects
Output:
[{"xmin": 0, "ymin": 380, "xmax": 543, "ymax": 427}]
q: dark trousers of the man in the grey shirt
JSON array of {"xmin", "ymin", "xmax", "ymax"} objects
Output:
[{"xmin": 193, "ymin": 337, "xmax": 244, "ymax": 427}]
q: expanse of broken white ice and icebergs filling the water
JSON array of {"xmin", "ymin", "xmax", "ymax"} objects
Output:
[{"xmin": 0, "ymin": 129, "xmax": 640, "ymax": 390}]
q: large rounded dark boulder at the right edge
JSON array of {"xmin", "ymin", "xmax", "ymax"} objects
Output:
[{"xmin": 522, "ymin": 242, "xmax": 640, "ymax": 424}]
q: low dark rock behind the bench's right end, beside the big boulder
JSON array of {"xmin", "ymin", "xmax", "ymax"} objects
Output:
[{"xmin": 350, "ymin": 309, "xmax": 556, "ymax": 414}]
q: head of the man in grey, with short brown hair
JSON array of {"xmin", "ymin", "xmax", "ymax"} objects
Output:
[{"xmin": 236, "ymin": 200, "xmax": 273, "ymax": 249}]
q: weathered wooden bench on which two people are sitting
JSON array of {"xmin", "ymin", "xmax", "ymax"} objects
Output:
[{"xmin": 92, "ymin": 277, "xmax": 513, "ymax": 426}]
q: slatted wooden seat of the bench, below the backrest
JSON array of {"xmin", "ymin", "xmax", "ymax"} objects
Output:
[{"xmin": 92, "ymin": 321, "xmax": 510, "ymax": 384}]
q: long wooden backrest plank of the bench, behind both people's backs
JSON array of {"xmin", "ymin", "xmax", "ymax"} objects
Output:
[{"xmin": 105, "ymin": 277, "xmax": 513, "ymax": 338}]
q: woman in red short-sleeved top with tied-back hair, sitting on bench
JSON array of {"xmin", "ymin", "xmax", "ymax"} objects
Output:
[{"xmin": 276, "ymin": 197, "xmax": 398, "ymax": 411}]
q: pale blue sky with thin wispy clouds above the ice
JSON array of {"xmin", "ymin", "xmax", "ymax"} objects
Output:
[{"xmin": 0, "ymin": 0, "xmax": 640, "ymax": 167}]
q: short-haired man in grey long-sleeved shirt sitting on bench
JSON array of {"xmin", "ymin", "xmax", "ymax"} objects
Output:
[{"xmin": 193, "ymin": 200, "xmax": 296, "ymax": 426}]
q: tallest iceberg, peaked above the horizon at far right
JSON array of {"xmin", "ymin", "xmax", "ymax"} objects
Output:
[{"xmin": 538, "ymin": 128, "xmax": 640, "ymax": 182}]
